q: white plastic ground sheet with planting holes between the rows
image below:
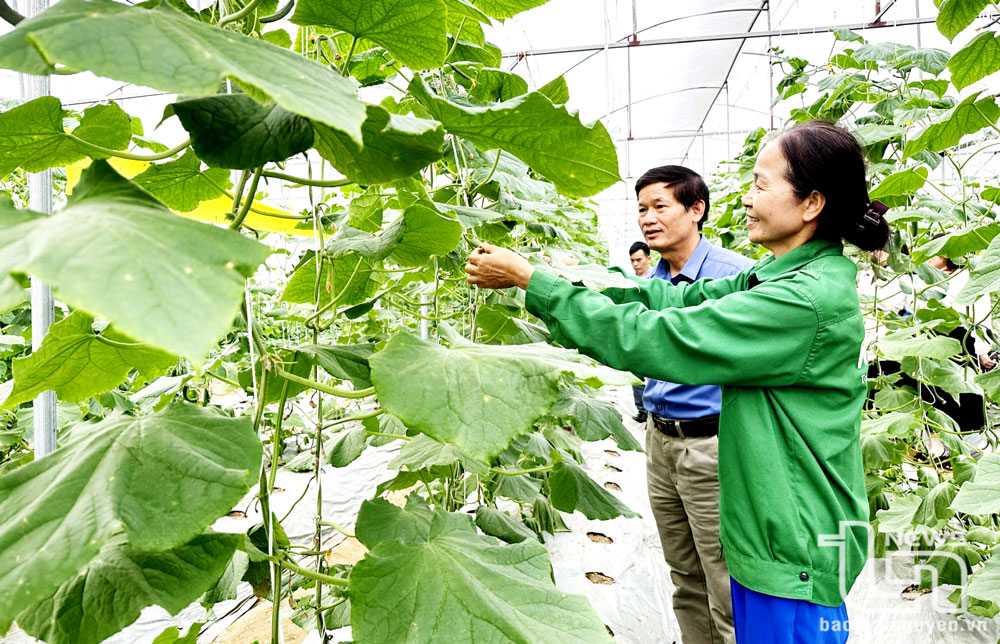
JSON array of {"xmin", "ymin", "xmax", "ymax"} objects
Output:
[{"xmin": 0, "ymin": 387, "xmax": 1000, "ymax": 644}]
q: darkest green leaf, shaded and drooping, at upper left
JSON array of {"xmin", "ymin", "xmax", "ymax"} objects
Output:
[{"xmin": 172, "ymin": 94, "xmax": 314, "ymax": 170}]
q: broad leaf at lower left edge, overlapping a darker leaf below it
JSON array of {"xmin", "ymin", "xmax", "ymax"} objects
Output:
[{"xmin": 0, "ymin": 404, "xmax": 261, "ymax": 621}]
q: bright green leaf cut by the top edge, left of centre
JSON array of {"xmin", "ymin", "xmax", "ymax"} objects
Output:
[{"xmin": 291, "ymin": 0, "xmax": 448, "ymax": 70}]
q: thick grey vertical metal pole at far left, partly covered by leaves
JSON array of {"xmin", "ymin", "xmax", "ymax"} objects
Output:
[{"xmin": 20, "ymin": 0, "xmax": 56, "ymax": 458}]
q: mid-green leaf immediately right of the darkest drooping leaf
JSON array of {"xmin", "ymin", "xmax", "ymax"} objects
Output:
[{"xmin": 315, "ymin": 105, "xmax": 444, "ymax": 184}]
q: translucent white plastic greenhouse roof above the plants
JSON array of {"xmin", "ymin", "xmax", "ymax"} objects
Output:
[{"xmin": 0, "ymin": 0, "xmax": 1000, "ymax": 266}]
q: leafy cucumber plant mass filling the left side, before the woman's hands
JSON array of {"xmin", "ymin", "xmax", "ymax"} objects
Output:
[{"xmin": 0, "ymin": 0, "xmax": 640, "ymax": 644}]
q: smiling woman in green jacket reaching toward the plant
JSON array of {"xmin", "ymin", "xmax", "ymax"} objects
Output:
[{"xmin": 466, "ymin": 121, "xmax": 889, "ymax": 644}]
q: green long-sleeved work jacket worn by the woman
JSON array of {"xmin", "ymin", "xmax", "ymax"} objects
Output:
[{"xmin": 526, "ymin": 240, "xmax": 868, "ymax": 606}]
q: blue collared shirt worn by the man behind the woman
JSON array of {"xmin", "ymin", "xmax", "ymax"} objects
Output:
[{"xmin": 642, "ymin": 235, "xmax": 754, "ymax": 418}]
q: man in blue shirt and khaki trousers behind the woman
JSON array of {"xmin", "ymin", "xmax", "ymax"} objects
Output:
[{"xmin": 635, "ymin": 165, "xmax": 753, "ymax": 644}]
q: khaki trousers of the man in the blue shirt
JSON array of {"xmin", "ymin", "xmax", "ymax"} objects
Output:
[{"xmin": 646, "ymin": 418, "xmax": 735, "ymax": 644}]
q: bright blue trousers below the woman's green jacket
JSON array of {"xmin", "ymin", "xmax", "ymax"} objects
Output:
[{"xmin": 729, "ymin": 578, "xmax": 849, "ymax": 644}]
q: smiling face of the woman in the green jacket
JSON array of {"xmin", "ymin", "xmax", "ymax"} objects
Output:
[{"xmin": 743, "ymin": 140, "xmax": 826, "ymax": 257}]
